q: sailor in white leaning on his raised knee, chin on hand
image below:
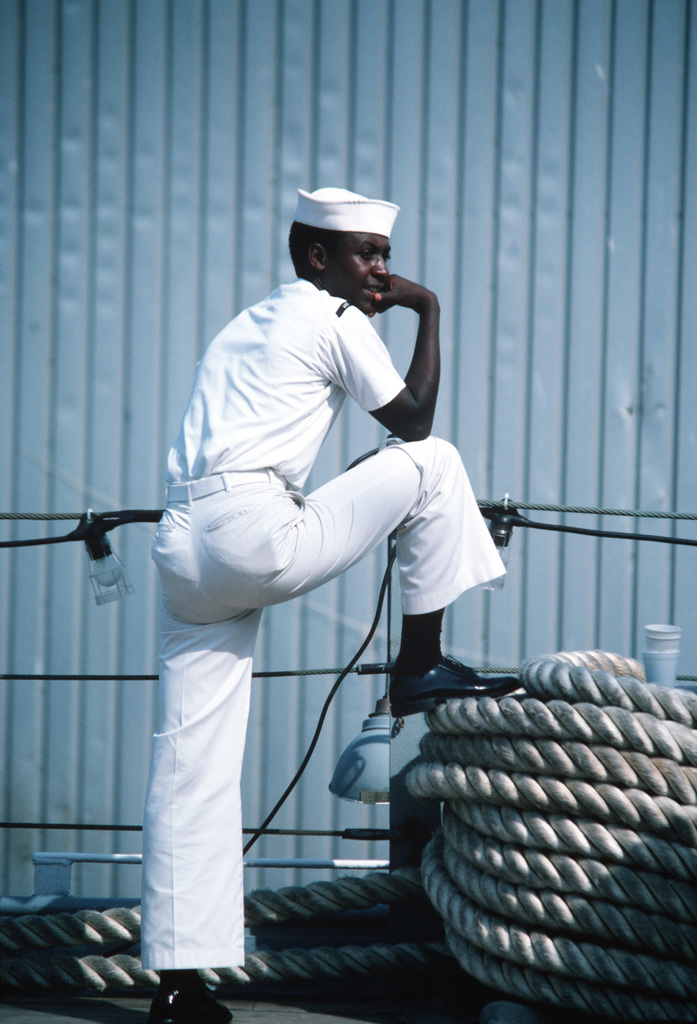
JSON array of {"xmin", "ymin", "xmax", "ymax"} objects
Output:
[{"xmin": 142, "ymin": 188, "xmax": 518, "ymax": 1024}]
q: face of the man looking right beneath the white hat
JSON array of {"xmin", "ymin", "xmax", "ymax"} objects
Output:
[{"xmin": 318, "ymin": 232, "xmax": 390, "ymax": 314}]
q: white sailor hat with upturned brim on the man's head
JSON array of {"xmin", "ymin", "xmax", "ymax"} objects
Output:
[{"xmin": 295, "ymin": 188, "xmax": 399, "ymax": 239}]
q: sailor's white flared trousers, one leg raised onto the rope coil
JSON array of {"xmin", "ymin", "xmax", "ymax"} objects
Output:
[{"xmin": 141, "ymin": 437, "xmax": 505, "ymax": 970}]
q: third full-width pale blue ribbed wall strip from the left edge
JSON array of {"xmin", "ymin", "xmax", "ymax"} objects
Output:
[{"xmin": 72, "ymin": 3, "xmax": 133, "ymax": 888}]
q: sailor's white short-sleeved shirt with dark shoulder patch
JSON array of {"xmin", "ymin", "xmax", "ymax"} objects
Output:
[{"xmin": 167, "ymin": 280, "xmax": 404, "ymax": 487}]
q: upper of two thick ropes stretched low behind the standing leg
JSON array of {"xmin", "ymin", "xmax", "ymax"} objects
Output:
[{"xmin": 0, "ymin": 867, "xmax": 424, "ymax": 951}]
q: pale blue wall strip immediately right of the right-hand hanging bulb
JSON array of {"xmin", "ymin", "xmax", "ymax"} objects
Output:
[{"xmin": 521, "ymin": 2, "xmax": 574, "ymax": 660}]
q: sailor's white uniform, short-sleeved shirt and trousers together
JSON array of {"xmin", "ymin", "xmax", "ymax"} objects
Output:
[{"xmin": 142, "ymin": 281, "xmax": 504, "ymax": 970}]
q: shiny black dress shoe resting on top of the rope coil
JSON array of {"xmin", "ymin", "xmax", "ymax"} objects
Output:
[{"xmin": 390, "ymin": 657, "xmax": 520, "ymax": 718}]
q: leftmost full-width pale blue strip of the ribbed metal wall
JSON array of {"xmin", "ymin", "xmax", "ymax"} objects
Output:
[{"xmin": 3, "ymin": 4, "xmax": 58, "ymax": 897}]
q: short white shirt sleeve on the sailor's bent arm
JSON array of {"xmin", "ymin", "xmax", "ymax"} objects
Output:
[{"xmin": 319, "ymin": 303, "xmax": 404, "ymax": 413}]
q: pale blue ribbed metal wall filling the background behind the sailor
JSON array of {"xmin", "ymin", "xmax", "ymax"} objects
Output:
[{"xmin": 0, "ymin": 0, "xmax": 697, "ymax": 895}]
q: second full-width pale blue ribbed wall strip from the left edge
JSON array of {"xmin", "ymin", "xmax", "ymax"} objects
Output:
[{"xmin": 41, "ymin": 3, "xmax": 94, "ymax": 888}]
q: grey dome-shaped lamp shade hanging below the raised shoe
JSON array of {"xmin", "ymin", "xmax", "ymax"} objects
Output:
[{"xmin": 330, "ymin": 696, "xmax": 390, "ymax": 804}]
